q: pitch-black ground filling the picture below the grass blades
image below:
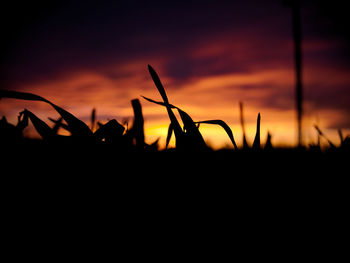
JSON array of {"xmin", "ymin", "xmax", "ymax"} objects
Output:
[{"xmin": 1, "ymin": 141, "xmax": 349, "ymax": 262}]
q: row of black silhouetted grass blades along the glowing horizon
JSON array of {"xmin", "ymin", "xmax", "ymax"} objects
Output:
[{"xmin": 0, "ymin": 65, "xmax": 350, "ymax": 164}]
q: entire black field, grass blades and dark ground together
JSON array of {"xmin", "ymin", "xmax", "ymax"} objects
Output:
[{"xmin": 0, "ymin": 67, "xmax": 350, "ymax": 260}]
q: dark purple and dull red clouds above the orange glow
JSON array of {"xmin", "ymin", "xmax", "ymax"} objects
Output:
[{"xmin": 0, "ymin": 0, "xmax": 350, "ymax": 131}]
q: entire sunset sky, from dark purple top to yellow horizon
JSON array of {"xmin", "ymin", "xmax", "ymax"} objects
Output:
[{"xmin": 0, "ymin": 0, "xmax": 350, "ymax": 147}]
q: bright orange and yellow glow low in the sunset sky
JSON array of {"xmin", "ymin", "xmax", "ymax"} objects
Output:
[{"xmin": 0, "ymin": 63, "xmax": 350, "ymax": 149}]
